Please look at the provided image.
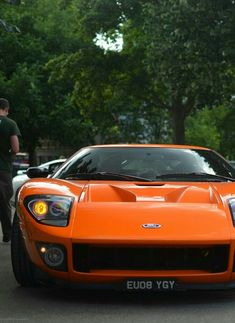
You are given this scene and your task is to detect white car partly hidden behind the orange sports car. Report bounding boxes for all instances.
[11,159,66,205]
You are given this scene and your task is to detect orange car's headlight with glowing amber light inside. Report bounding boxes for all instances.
[24,195,73,227]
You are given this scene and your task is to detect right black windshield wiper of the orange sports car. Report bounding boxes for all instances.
[156,173,235,182]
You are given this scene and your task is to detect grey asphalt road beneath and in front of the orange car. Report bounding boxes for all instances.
[0,233,235,323]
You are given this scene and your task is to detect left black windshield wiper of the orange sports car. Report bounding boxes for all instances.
[63,172,152,182]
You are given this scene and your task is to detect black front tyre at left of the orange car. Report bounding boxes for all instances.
[11,212,36,287]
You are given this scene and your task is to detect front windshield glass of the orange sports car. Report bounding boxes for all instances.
[53,146,235,181]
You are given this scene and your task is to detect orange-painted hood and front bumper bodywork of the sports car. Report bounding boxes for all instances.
[17,145,235,290]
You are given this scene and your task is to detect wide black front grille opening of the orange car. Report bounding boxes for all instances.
[73,244,229,273]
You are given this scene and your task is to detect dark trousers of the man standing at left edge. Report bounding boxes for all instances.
[0,171,13,236]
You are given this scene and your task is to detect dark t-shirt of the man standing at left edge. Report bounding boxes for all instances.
[0,116,20,173]
